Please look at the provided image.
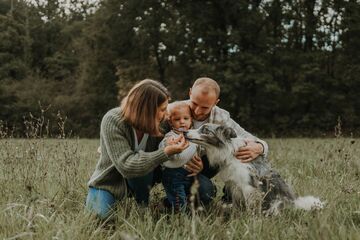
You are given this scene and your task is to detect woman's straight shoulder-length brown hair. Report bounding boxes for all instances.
[120,79,170,135]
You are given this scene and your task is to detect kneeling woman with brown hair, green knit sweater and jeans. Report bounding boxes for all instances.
[86,79,189,218]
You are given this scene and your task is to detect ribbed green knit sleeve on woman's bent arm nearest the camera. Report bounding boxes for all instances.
[100,114,168,178]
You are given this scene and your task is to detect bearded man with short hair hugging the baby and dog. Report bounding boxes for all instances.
[184,77,268,200]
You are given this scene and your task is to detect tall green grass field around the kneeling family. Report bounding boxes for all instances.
[0,138,360,239]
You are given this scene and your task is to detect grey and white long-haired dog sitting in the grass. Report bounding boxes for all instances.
[184,123,324,215]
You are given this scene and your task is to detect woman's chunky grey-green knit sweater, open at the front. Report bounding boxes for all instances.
[88,107,169,199]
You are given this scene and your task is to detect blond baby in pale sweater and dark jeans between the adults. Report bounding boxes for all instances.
[159,102,197,210]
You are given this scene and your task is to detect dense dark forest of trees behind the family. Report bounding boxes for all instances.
[0,0,360,137]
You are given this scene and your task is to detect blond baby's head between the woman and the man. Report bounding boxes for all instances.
[167,101,192,130]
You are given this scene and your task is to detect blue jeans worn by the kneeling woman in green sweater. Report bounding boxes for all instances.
[86,172,155,219]
